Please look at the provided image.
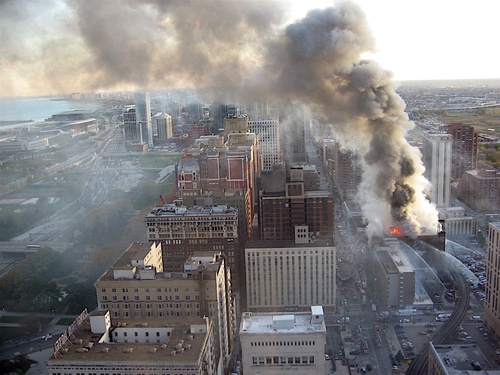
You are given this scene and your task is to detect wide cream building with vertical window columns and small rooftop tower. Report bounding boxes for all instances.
[245,239,336,311]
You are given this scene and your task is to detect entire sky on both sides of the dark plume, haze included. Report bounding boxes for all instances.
[0,0,500,97]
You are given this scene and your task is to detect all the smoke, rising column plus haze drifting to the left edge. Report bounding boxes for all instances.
[0,0,437,237]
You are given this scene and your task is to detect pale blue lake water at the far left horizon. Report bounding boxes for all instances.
[0,98,99,122]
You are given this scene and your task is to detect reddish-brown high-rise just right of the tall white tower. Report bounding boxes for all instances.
[446,123,478,179]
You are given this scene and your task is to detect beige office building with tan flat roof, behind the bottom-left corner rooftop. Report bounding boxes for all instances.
[95,243,236,372]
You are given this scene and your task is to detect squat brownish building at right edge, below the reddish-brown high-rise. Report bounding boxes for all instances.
[458,170,500,213]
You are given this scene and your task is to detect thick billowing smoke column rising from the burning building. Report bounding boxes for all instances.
[258,2,438,237]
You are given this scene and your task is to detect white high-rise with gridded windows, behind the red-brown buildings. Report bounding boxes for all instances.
[248,120,281,170]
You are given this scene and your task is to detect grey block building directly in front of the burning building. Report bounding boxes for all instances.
[373,238,415,309]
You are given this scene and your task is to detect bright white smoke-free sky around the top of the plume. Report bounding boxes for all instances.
[294,0,500,80]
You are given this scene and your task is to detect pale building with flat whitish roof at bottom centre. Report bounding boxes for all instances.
[240,306,326,375]
